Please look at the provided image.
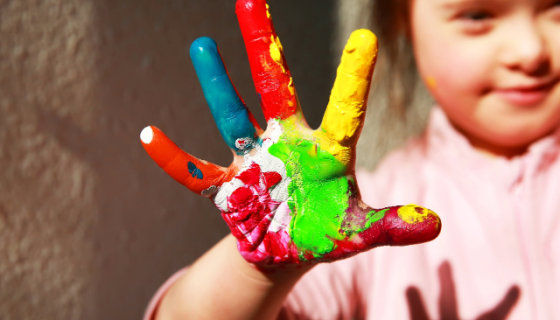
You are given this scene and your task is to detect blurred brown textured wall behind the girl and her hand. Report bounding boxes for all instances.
[0,0,432,320]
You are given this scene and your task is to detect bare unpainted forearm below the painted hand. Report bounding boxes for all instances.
[156,235,311,320]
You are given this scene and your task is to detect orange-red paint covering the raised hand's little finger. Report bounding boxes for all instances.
[140,126,231,194]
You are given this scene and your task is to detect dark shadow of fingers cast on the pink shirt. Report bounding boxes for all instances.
[406,261,521,320]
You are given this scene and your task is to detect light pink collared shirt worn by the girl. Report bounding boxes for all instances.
[145,107,560,320]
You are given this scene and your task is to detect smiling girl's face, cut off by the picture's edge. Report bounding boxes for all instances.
[410,0,560,156]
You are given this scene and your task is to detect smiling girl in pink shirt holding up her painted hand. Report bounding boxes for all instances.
[141,0,560,320]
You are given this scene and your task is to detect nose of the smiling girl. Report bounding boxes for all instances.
[502,19,550,76]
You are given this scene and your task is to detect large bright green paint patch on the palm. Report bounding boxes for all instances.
[268,140,356,256]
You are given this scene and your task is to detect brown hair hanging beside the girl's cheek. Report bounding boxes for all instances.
[372,0,418,116]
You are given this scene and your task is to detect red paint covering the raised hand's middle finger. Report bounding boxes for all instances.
[235,0,297,121]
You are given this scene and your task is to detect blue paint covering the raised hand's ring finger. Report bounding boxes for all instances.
[190,37,257,155]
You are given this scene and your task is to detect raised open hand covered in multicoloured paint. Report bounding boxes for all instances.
[141,0,441,265]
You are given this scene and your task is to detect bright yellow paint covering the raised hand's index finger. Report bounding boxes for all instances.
[321,29,377,164]
